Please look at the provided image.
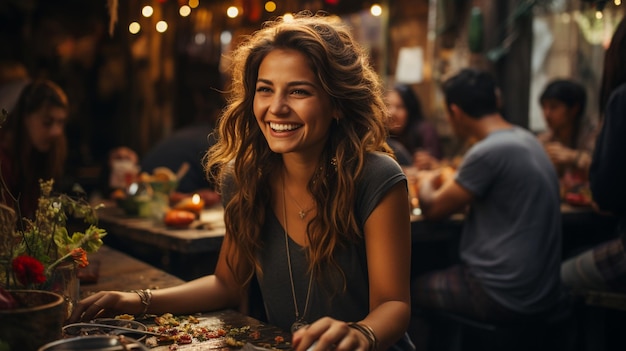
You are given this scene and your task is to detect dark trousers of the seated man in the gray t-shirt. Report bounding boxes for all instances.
[411,264,525,322]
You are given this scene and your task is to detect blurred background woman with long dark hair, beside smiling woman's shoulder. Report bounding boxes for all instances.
[386,84,442,169]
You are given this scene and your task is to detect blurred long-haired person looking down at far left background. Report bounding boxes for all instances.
[0,80,69,218]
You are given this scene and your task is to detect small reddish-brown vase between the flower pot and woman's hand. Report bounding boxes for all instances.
[44,262,80,319]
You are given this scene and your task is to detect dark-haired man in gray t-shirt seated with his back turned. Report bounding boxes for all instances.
[413,69,561,321]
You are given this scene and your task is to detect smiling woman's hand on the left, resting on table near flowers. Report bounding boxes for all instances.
[68,291,143,323]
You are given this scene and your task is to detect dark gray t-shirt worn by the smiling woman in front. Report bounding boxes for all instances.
[258,153,409,330]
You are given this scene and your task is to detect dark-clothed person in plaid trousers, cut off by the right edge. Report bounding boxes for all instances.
[561,20,626,293]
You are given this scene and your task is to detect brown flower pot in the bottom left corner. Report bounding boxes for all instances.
[0,290,66,351]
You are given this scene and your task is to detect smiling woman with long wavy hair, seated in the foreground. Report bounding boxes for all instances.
[71,12,413,351]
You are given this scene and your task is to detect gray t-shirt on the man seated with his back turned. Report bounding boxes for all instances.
[456,127,561,313]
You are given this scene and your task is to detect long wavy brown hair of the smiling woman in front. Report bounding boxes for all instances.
[206,12,392,284]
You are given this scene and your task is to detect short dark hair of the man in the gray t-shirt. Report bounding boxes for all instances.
[442,68,499,118]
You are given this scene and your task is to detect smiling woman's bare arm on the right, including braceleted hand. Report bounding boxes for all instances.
[292,183,411,351]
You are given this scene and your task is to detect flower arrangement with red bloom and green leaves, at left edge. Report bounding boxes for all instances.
[0,180,106,296]
